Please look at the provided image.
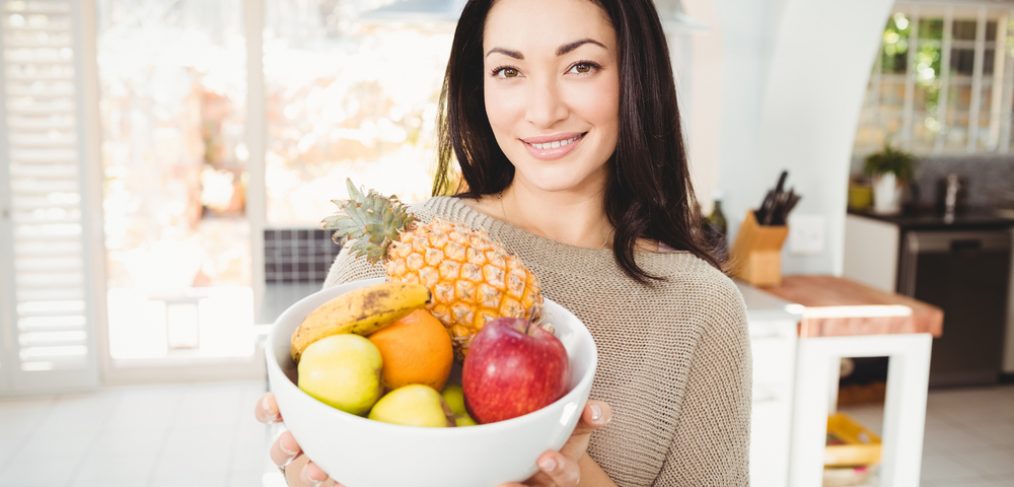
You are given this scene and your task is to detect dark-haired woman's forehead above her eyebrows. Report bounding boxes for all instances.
[483,0,615,52]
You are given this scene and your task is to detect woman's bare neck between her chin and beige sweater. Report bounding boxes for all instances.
[500,182,612,249]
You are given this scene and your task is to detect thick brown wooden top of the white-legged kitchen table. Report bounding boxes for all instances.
[762,275,944,337]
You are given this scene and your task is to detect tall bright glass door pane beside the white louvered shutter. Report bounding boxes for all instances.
[97,0,255,368]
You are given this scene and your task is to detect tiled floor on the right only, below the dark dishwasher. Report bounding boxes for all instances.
[845,386,1014,487]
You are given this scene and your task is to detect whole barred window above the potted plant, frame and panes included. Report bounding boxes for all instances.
[854,2,1014,155]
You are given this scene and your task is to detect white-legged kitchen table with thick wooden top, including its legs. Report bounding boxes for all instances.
[764,276,943,487]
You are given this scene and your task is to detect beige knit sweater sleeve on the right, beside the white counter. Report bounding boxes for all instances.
[654,281,751,487]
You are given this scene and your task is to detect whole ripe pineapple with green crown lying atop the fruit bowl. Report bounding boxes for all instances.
[322,181,542,356]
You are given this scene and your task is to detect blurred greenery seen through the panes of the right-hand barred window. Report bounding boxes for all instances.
[854,10,1014,155]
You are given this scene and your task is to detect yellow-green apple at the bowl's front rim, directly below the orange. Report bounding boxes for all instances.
[369,384,448,428]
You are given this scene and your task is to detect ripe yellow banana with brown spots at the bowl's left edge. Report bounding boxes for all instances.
[290,281,431,362]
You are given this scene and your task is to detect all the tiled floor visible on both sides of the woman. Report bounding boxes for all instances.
[0,380,1014,487]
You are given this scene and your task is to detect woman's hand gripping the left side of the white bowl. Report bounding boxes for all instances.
[255,393,342,487]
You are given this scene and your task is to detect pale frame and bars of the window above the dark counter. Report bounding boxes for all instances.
[854,1,1014,155]
